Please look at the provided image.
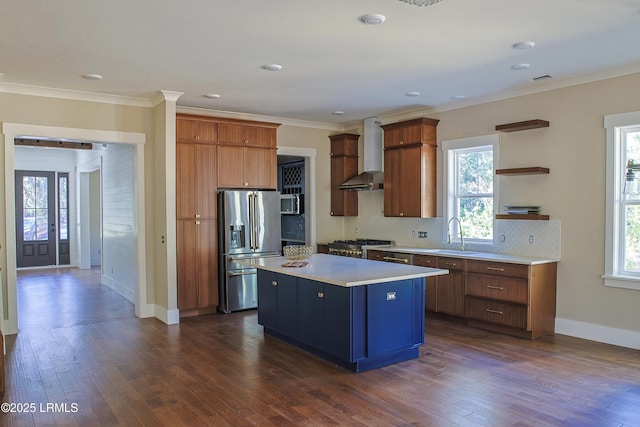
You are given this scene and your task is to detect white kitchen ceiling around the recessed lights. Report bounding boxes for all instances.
[0,0,640,124]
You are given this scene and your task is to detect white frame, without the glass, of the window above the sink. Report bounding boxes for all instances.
[441,134,500,245]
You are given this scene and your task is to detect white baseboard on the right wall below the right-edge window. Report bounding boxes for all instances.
[556,317,640,350]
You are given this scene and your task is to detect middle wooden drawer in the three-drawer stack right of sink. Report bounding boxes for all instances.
[466,273,529,304]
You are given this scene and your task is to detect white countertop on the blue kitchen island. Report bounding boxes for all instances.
[237,254,449,287]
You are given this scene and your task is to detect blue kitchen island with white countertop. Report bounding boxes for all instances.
[238,254,448,372]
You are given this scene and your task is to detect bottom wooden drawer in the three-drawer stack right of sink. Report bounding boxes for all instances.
[465,296,527,329]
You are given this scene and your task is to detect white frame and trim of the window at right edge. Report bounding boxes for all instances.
[602,111,640,290]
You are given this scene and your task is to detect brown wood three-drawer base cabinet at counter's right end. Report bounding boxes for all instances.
[466,260,557,339]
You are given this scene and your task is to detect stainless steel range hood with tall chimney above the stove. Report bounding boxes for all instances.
[338,117,384,191]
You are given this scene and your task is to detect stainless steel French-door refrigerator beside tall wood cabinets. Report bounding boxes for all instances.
[218,190,281,313]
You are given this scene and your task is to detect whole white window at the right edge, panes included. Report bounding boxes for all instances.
[603,112,640,289]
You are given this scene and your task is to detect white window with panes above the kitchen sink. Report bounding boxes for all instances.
[442,134,498,244]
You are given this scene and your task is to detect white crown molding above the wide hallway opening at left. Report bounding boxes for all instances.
[0,82,153,108]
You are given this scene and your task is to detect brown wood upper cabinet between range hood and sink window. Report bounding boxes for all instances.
[382,118,438,218]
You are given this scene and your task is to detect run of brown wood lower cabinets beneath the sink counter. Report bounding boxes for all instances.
[367,250,557,339]
